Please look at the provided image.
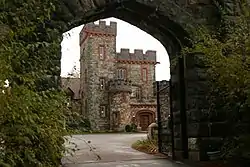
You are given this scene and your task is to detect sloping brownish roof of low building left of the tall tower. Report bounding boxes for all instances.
[61,78,80,99]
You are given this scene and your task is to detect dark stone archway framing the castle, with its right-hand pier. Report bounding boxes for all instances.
[3,0,238,162]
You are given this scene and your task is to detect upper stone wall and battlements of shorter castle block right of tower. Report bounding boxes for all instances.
[116,49,156,103]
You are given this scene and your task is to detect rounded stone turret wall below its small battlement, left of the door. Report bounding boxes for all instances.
[110,92,132,131]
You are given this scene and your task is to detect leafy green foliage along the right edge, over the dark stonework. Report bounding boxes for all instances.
[183,1,250,163]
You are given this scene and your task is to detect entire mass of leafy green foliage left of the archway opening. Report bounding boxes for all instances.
[0,0,70,167]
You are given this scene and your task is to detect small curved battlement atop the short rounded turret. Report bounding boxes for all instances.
[108,79,132,93]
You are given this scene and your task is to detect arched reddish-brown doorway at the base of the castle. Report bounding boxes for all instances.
[135,109,155,131]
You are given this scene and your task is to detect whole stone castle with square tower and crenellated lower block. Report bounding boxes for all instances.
[80,21,157,131]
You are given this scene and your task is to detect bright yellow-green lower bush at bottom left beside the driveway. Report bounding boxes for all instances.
[0,86,67,167]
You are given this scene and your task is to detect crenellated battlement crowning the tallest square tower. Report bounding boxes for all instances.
[80,20,117,35]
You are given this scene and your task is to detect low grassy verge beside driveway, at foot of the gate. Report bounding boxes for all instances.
[132,139,158,154]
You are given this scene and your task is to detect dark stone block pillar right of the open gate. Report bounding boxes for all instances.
[186,53,227,161]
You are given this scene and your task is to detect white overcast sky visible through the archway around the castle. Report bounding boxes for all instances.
[61,18,170,81]
